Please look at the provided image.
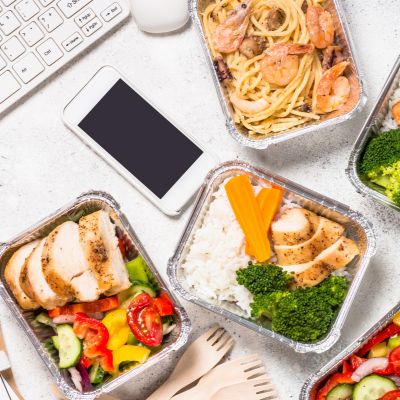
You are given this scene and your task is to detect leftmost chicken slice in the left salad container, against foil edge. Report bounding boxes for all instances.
[4,240,39,310]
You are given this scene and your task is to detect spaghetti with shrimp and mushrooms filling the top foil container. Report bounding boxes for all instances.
[202,0,350,138]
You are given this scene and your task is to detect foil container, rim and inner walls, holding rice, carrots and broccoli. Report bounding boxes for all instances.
[167,161,376,353]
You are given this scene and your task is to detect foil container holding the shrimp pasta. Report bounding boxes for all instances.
[189,0,367,149]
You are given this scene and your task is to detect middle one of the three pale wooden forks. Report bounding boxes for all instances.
[172,355,265,400]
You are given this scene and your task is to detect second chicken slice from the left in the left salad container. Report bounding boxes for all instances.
[20,239,71,310]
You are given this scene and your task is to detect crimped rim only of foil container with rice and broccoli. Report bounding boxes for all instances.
[167,160,376,353]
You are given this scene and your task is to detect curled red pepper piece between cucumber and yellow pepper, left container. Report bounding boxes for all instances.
[73,313,114,372]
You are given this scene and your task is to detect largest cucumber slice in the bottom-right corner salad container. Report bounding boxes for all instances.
[353,374,397,400]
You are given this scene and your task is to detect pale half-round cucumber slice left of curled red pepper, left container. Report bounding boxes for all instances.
[57,324,82,368]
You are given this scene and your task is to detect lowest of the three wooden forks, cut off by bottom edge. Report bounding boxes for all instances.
[210,375,279,400]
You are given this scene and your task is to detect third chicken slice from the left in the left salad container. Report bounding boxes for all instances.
[42,221,100,302]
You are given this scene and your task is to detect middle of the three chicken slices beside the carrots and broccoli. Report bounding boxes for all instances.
[275,217,344,265]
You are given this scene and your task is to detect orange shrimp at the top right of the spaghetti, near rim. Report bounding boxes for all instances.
[306,5,335,49]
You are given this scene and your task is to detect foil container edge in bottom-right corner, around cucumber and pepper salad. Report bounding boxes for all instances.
[300,303,400,400]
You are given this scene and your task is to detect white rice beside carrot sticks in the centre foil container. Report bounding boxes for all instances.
[181,182,297,317]
